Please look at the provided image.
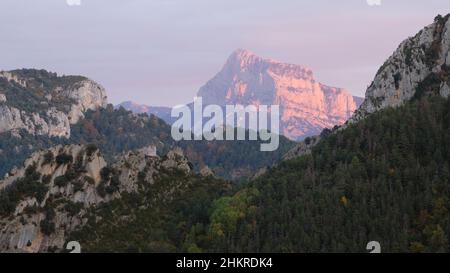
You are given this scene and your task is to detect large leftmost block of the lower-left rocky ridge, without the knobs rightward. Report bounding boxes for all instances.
[0,145,106,252]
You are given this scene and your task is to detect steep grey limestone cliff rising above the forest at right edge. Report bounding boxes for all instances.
[351,15,450,122]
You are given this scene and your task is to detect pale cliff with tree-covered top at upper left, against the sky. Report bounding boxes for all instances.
[0,70,107,138]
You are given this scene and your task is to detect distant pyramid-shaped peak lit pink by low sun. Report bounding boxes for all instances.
[198,50,362,140]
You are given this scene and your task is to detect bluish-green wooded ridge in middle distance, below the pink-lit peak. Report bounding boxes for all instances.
[0,105,294,179]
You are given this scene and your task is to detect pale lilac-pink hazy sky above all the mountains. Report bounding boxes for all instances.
[0,0,450,106]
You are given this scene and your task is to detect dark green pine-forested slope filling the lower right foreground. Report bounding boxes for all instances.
[66,97,450,252]
